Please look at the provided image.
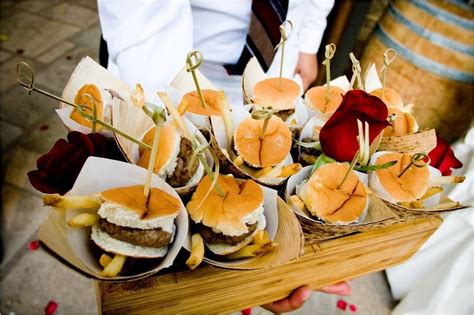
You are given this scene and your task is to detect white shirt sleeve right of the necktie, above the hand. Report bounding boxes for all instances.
[298,0,334,54]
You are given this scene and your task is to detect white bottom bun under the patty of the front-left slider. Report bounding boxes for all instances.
[91,225,168,258]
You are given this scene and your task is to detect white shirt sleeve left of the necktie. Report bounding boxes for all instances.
[98,0,193,95]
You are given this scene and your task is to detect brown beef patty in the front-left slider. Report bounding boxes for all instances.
[99,219,171,248]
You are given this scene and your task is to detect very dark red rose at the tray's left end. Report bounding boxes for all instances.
[28,131,123,195]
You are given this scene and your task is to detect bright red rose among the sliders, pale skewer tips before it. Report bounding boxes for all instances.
[319,90,390,162]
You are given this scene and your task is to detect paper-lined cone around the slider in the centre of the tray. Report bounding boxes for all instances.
[211,106,293,187]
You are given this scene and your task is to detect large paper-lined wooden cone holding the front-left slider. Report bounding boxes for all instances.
[39,157,189,281]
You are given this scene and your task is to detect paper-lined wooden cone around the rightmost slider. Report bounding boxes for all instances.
[369,151,469,213]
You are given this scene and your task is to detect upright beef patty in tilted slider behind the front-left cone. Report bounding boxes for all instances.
[166,137,199,187]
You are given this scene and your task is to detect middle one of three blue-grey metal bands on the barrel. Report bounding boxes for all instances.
[388,4,474,55]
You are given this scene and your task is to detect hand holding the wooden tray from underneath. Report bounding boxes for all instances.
[262,282,351,314]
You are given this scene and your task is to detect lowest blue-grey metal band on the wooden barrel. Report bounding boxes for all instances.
[375,24,474,83]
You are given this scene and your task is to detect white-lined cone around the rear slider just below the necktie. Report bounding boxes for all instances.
[242,57,308,129]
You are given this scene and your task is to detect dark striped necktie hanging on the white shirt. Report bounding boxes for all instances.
[224,0,288,75]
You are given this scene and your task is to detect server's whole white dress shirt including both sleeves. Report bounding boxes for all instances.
[98,0,334,102]
